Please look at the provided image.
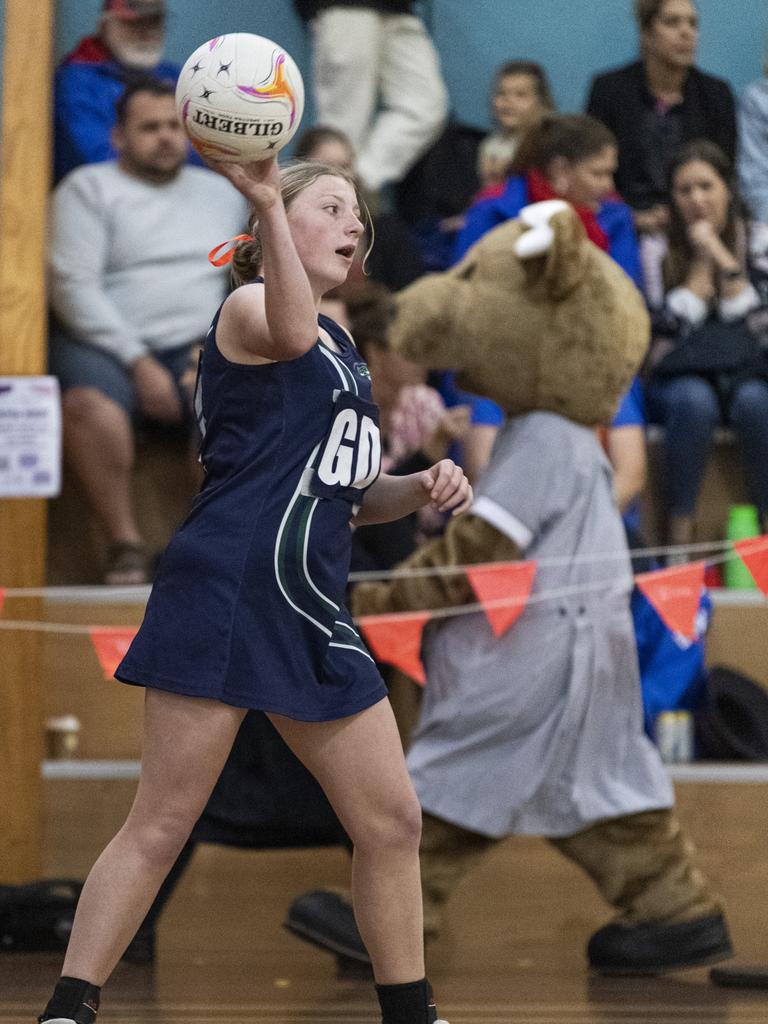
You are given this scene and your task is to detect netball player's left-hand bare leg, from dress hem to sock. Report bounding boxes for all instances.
[62,689,245,986]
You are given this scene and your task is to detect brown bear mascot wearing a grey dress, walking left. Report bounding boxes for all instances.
[287,201,731,974]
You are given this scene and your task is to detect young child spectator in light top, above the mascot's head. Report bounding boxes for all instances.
[477,60,555,199]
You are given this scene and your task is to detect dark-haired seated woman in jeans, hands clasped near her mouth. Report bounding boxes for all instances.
[648,140,768,545]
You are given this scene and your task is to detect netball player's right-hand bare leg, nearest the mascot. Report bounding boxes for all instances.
[269,699,424,985]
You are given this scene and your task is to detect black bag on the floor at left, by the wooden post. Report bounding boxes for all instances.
[0,879,83,952]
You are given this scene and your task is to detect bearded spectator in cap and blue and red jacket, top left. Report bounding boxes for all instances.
[53,0,202,181]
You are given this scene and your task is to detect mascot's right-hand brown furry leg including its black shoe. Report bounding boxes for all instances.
[550,810,732,974]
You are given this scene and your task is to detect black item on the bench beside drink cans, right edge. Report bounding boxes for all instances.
[695,666,768,761]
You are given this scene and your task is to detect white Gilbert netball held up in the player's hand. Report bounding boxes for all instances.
[176,32,304,164]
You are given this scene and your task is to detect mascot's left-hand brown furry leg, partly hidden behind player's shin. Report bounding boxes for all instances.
[419,811,498,939]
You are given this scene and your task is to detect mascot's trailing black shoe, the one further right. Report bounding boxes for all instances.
[587,913,733,975]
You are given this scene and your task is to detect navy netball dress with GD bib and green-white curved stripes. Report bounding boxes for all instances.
[116,301,386,722]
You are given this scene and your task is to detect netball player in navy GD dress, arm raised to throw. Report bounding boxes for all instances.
[40,159,472,1024]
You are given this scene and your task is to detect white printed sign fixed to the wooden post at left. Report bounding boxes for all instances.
[0,377,61,498]
